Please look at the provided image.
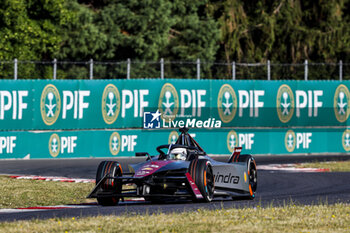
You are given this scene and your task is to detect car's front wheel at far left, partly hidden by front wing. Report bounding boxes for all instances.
[96,161,123,206]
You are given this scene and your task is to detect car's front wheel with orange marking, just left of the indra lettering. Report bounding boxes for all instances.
[189,159,214,202]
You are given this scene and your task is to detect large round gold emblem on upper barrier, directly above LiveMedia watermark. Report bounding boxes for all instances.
[158,83,179,121]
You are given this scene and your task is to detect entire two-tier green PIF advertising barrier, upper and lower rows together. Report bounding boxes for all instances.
[0,79,350,159]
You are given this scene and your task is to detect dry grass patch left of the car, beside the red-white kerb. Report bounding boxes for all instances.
[0,176,95,208]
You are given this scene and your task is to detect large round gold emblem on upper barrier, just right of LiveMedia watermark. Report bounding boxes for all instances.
[217,84,237,123]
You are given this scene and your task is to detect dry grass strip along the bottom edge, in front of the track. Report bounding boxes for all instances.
[0,204,350,233]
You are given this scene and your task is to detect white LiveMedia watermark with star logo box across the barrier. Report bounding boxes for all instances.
[143,110,222,129]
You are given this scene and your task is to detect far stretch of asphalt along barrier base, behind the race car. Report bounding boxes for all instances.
[0,155,350,179]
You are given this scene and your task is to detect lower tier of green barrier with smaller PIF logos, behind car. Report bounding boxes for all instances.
[0,128,350,159]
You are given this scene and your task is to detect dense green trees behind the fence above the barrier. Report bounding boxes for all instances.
[0,0,350,78]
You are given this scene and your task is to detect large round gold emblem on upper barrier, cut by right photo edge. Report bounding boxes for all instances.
[334,84,350,122]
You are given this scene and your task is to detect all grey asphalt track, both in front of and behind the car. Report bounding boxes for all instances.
[0,156,350,221]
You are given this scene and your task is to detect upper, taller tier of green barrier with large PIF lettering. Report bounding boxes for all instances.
[0,79,350,131]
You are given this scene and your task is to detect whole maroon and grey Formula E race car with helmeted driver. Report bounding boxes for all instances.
[88,128,257,206]
